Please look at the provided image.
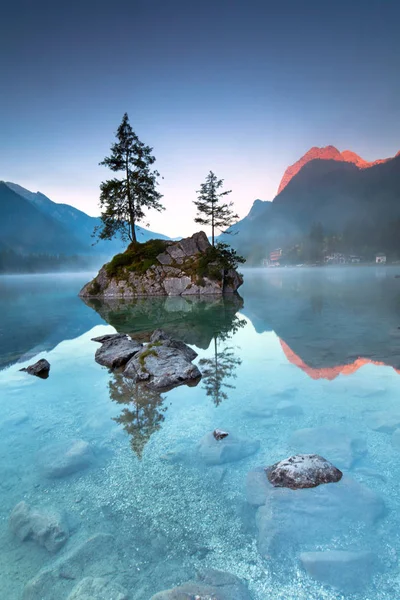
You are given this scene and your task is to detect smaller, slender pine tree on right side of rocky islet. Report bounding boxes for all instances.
[194,171,239,246]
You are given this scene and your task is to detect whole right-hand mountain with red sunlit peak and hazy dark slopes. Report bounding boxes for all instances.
[221,146,400,264]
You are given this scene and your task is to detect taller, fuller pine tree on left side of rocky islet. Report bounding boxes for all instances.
[95,113,164,242]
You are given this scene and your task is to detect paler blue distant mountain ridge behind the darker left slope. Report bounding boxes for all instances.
[4,182,169,256]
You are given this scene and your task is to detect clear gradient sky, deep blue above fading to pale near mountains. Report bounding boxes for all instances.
[0,0,400,237]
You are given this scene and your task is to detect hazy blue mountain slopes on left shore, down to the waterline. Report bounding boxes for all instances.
[0,181,169,273]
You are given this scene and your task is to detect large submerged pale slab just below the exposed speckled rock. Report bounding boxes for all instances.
[252,475,385,557]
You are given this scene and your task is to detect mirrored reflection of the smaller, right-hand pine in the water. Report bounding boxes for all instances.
[199,316,246,406]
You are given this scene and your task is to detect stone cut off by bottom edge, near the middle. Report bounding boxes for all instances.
[150,569,251,600]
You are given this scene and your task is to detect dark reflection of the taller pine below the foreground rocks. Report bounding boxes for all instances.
[109,373,167,459]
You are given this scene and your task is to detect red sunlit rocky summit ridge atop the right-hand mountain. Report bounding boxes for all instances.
[278,146,391,194]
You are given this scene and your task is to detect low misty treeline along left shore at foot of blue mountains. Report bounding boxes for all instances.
[0,250,101,273]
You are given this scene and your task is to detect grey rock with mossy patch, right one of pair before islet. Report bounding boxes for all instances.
[124,345,201,390]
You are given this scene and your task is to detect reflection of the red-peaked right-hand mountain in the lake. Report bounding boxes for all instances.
[243,267,400,380]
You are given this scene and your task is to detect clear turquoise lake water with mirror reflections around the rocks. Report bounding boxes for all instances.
[0,268,400,600]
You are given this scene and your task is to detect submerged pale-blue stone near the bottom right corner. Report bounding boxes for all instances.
[300,550,377,593]
